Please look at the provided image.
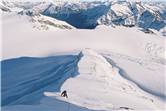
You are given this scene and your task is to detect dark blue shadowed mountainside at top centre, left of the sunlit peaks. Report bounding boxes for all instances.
[42,4,109,29]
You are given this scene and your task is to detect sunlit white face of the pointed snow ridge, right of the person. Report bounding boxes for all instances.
[61,49,165,110]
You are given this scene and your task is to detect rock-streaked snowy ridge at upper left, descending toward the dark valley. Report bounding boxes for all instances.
[0,2,74,30]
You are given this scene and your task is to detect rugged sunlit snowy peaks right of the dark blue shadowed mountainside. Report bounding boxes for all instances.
[99,1,166,30]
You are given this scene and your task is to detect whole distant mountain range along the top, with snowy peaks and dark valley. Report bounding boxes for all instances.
[2,0,166,35]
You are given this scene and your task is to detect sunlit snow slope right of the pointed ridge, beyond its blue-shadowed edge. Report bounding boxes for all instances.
[105,53,166,100]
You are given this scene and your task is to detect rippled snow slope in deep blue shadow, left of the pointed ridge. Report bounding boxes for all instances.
[1,55,79,106]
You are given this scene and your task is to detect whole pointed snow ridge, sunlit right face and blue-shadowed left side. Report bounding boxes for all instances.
[2,49,163,111]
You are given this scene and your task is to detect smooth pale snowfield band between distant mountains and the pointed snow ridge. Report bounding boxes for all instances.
[2,13,165,59]
